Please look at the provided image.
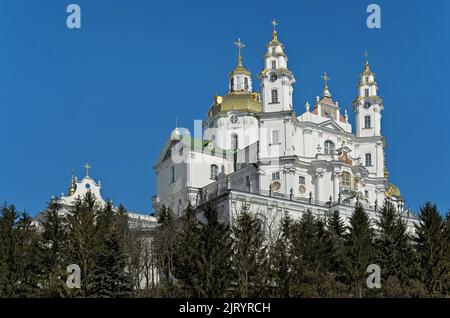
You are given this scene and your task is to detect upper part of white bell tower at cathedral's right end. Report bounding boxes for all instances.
[352,52,383,137]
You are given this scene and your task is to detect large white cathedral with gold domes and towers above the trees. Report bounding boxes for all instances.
[153,21,417,231]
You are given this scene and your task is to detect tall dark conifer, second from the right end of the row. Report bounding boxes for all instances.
[376,200,414,294]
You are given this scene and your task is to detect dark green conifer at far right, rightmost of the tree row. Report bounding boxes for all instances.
[415,202,449,297]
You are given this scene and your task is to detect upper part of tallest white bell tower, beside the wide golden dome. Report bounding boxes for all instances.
[258,20,295,112]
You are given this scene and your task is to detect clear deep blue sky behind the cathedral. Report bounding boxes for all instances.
[0,0,450,215]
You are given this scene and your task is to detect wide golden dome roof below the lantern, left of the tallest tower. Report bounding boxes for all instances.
[208,92,262,116]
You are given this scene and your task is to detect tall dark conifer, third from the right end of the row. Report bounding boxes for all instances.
[345,203,376,296]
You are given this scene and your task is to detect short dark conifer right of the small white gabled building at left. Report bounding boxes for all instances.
[92,228,133,297]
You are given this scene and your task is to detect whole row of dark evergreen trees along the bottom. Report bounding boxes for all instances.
[0,193,450,297]
